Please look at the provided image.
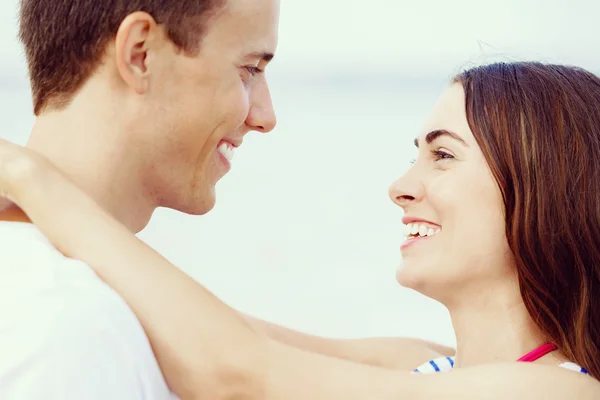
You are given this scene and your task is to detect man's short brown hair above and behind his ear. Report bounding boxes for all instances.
[19,0,225,115]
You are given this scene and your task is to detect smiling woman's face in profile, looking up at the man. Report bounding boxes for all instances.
[389,84,514,303]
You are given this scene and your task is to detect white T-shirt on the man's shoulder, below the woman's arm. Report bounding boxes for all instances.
[0,220,176,399]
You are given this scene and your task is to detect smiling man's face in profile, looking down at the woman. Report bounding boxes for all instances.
[136,0,279,214]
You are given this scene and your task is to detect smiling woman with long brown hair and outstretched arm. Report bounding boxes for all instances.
[0,63,600,399]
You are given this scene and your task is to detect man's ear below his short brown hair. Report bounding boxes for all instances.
[115,11,160,94]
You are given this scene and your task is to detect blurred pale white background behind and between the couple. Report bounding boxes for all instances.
[0,0,600,345]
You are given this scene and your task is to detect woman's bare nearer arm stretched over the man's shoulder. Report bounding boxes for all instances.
[0,141,600,400]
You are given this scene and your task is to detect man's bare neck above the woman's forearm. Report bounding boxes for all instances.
[27,98,156,232]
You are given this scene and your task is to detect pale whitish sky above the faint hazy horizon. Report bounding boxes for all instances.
[0,0,600,79]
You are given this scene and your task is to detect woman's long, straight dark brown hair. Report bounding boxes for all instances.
[454,62,600,379]
